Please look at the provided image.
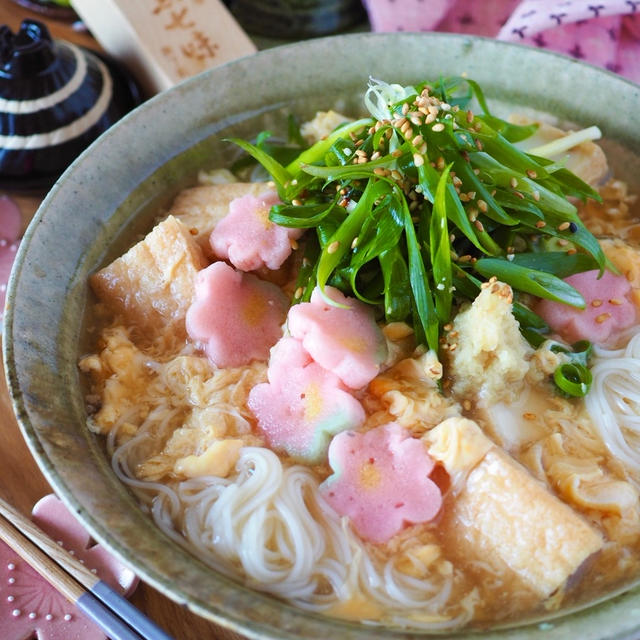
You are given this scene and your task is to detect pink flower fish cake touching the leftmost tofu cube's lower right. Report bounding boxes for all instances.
[186,262,289,368]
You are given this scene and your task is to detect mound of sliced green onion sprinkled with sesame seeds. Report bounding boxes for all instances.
[232,77,609,362]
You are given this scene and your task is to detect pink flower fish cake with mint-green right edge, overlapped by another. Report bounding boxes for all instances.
[248,337,365,464]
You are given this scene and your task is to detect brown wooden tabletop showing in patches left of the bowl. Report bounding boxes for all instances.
[0,0,244,640]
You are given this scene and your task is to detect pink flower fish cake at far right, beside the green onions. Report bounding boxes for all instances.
[535,270,637,344]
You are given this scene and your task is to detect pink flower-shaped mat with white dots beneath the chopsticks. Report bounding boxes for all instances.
[0,495,138,640]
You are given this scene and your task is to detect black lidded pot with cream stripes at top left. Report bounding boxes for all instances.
[0,20,141,190]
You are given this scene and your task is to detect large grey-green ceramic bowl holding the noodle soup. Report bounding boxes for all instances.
[4,34,640,640]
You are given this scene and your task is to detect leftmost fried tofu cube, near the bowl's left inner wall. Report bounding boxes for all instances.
[90,216,206,337]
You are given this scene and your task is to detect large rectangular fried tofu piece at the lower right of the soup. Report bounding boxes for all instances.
[424,418,603,598]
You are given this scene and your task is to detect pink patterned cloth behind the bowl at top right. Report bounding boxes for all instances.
[365,0,640,83]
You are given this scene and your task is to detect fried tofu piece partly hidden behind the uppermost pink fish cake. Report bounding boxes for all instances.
[169,182,269,258]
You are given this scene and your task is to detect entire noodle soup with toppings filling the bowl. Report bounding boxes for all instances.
[80,78,640,630]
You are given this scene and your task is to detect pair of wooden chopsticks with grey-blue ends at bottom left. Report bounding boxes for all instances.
[0,498,173,640]
